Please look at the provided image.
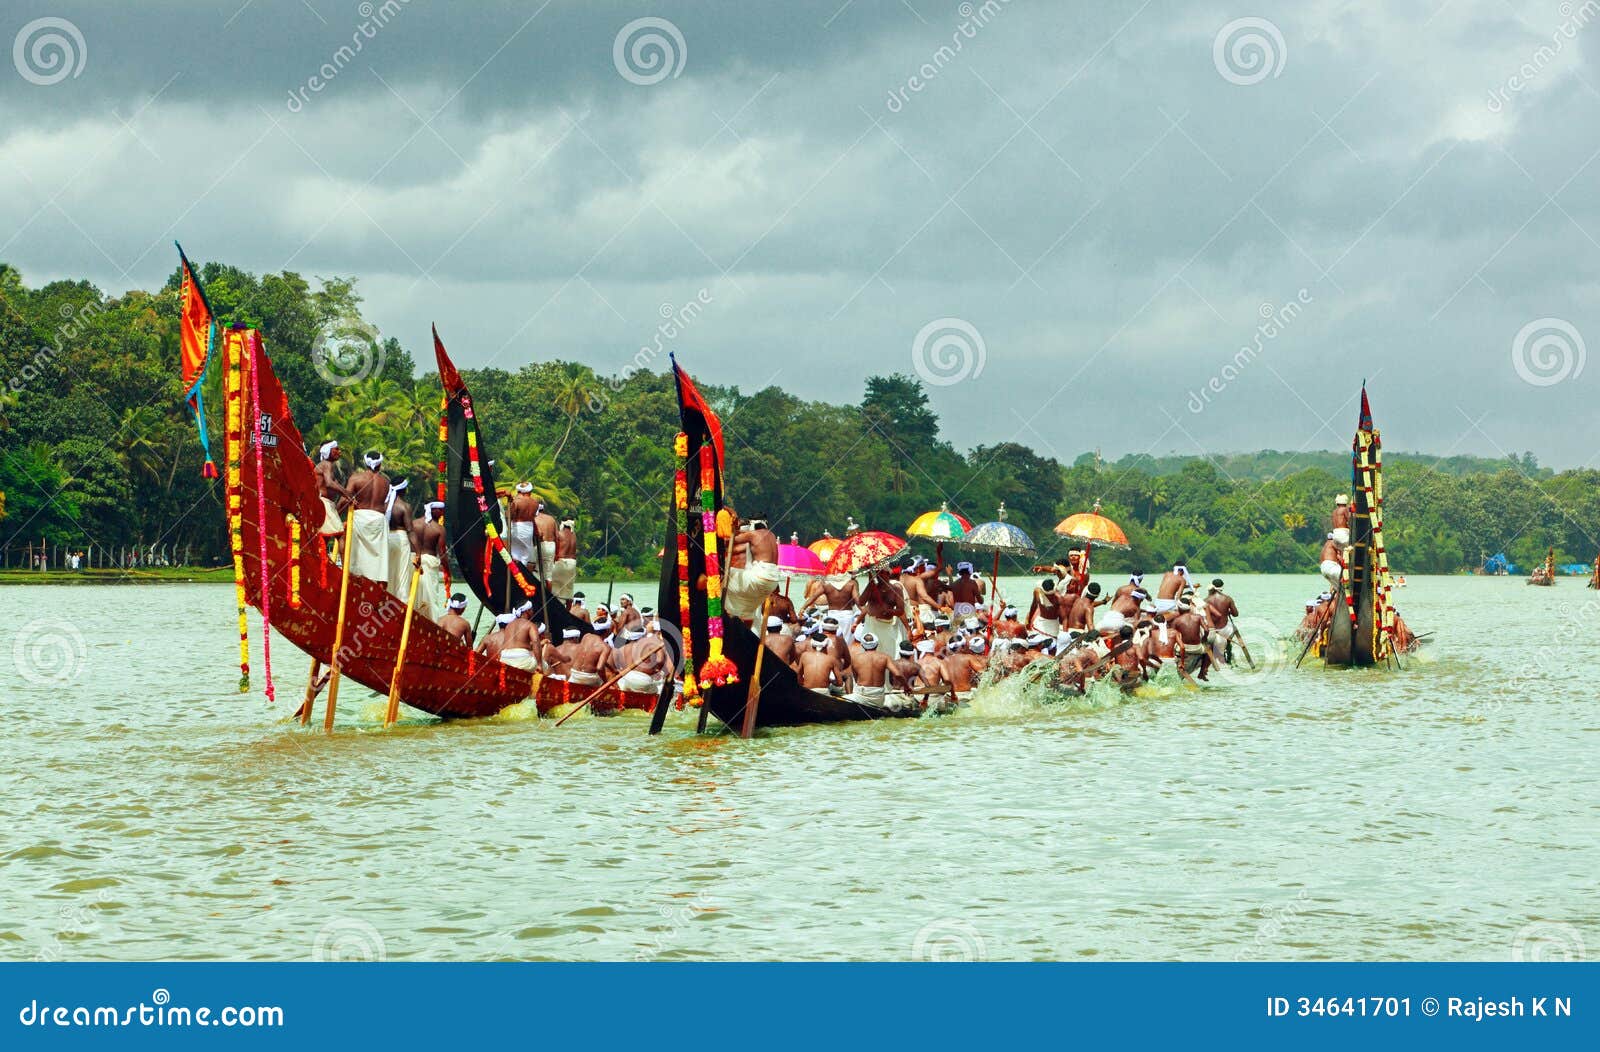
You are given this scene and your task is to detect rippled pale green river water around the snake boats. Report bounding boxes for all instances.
[0,576,1600,959]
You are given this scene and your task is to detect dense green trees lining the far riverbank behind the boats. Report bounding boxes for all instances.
[0,264,1600,572]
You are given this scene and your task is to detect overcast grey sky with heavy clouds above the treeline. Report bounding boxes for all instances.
[9,0,1600,467]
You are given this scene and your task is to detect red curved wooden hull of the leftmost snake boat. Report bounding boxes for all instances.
[224,329,554,718]
